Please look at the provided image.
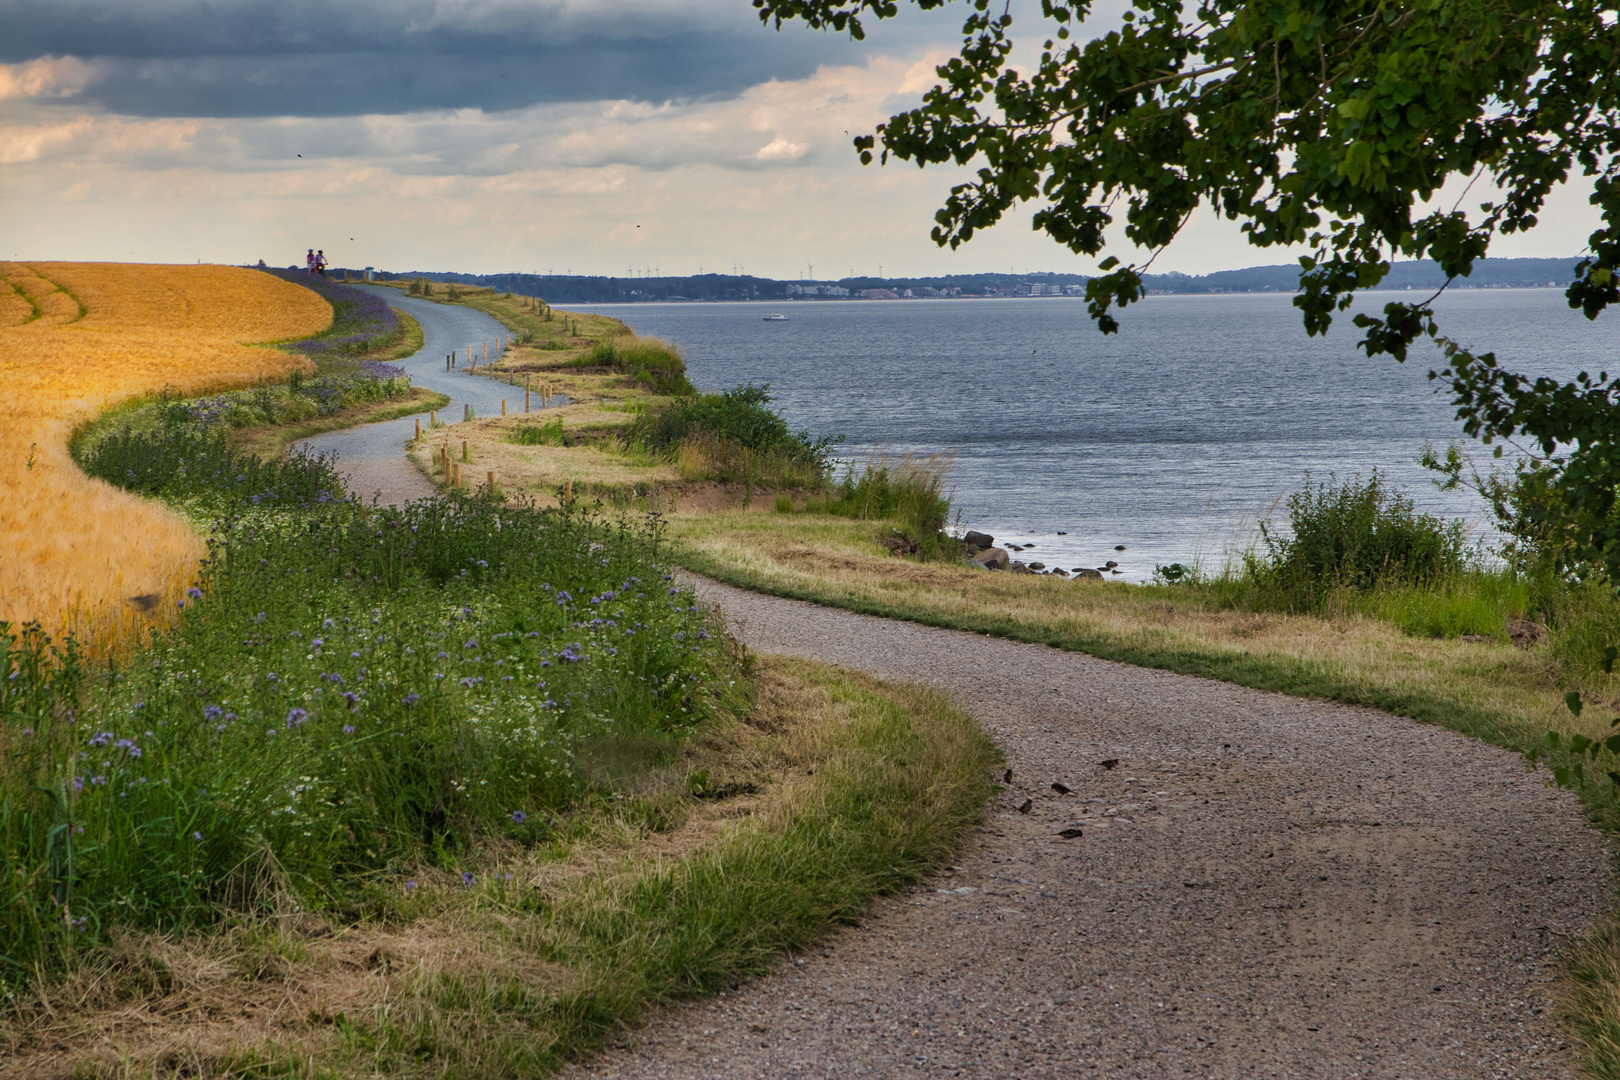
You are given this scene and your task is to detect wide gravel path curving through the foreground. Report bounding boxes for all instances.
[572,583,1610,1080]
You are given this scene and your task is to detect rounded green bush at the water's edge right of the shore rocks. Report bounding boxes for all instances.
[1246,470,1474,609]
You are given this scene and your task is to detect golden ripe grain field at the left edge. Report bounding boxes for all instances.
[0,262,332,649]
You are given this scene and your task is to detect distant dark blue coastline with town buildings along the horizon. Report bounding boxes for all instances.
[325,257,1580,304]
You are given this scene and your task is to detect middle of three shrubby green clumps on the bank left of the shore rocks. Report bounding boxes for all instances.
[622,385,836,489]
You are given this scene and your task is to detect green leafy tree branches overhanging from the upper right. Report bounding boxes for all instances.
[753,0,1620,581]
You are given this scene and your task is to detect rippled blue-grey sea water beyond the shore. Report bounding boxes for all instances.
[590,288,1620,580]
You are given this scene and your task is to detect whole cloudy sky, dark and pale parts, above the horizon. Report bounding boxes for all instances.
[0,0,1594,280]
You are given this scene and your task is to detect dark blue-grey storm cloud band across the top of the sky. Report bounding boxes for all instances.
[0,0,961,117]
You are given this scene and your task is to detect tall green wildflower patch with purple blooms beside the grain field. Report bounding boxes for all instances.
[0,426,739,984]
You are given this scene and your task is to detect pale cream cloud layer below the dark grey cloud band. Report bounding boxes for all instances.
[0,38,1591,277]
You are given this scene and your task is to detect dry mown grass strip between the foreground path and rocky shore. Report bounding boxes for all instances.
[671,513,1620,750]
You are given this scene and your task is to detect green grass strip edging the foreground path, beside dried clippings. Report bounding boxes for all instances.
[281,662,998,1077]
